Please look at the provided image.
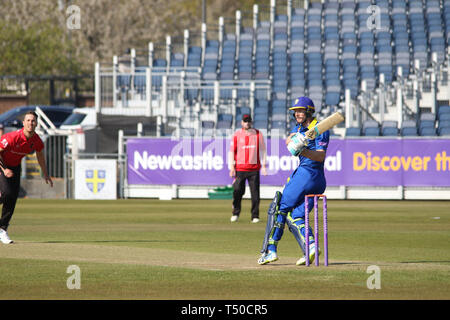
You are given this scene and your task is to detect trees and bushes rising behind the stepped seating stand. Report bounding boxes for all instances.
[0,0,284,75]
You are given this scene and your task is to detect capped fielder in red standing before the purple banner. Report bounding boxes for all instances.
[229,114,267,223]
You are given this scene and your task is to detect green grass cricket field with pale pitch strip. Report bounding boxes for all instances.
[0,199,450,300]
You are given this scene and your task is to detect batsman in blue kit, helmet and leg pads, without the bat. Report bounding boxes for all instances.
[258,97,330,265]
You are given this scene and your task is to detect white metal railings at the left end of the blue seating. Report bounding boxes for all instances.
[96,63,271,110]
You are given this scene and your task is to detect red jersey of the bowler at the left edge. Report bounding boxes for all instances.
[0,128,44,167]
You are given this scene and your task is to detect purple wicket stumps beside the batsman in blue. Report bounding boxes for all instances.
[305,194,328,267]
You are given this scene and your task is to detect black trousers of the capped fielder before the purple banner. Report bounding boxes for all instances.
[232,171,260,219]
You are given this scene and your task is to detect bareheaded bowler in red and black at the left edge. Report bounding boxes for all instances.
[0,111,53,244]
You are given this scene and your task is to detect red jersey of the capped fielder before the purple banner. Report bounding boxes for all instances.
[230,128,266,171]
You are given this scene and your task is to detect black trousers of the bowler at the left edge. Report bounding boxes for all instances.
[0,166,22,230]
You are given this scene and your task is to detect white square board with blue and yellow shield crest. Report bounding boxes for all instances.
[75,160,117,200]
